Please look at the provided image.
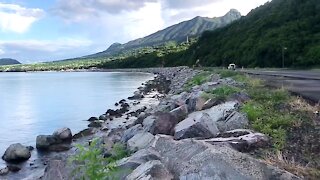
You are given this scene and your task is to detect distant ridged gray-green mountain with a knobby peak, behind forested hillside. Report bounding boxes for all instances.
[87,9,241,57]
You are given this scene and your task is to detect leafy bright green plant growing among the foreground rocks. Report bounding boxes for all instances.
[69,139,131,179]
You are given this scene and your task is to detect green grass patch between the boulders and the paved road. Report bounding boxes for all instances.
[241,79,297,151]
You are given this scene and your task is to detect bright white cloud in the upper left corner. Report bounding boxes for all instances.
[0,2,44,33]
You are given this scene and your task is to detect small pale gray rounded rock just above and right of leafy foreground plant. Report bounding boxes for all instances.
[127,132,154,151]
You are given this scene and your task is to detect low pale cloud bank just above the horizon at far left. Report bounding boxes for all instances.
[0,38,93,61]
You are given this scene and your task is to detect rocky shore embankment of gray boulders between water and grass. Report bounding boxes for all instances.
[0,67,299,180]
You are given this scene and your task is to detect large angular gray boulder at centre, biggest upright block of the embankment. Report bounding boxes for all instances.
[174,112,219,139]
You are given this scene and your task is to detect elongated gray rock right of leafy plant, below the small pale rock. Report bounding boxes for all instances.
[117,148,161,170]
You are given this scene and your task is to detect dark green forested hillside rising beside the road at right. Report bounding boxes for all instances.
[178,0,320,67]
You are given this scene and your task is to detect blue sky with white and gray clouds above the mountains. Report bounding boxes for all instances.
[0,0,268,63]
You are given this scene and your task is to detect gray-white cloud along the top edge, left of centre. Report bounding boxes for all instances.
[51,0,157,22]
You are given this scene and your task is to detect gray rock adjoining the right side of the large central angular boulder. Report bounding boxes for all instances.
[217,111,249,132]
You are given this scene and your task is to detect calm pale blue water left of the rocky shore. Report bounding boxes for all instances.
[0,72,153,163]
